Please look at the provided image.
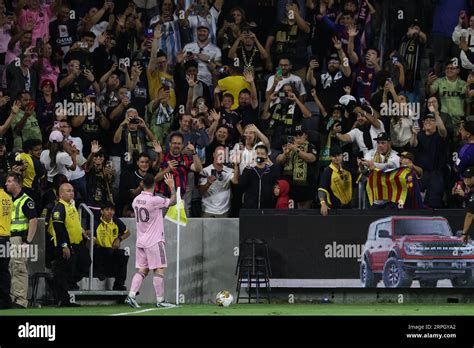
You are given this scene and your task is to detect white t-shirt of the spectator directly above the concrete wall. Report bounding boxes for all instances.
[199,164,234,215]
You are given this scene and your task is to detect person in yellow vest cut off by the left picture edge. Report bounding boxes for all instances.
[0,174,13,309]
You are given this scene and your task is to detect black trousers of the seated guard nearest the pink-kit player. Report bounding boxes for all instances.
[94,246,128,286]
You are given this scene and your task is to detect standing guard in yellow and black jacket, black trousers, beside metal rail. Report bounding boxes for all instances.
[48,183,91,307]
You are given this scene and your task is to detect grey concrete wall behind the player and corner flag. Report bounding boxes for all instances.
[63,219,239,304]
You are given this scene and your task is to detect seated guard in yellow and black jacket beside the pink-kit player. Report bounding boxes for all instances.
[94,202,130,291]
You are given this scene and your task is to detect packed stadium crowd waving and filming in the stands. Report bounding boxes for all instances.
[0,0,474,223]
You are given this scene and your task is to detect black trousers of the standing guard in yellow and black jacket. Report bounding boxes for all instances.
[52,243,91,302]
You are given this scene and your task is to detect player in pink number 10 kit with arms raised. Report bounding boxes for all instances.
[125,174,176,308]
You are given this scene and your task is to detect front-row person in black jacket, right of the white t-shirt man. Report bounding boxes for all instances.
[232,145,277,209]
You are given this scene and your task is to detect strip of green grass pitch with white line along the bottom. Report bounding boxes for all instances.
[0,303,474,316]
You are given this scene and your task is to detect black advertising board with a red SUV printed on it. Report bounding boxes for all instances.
[240,210,468,288]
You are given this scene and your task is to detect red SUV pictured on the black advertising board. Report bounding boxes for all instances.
[360,216,474,288]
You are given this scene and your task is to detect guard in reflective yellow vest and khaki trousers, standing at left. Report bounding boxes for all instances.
[6,172,38,308]
